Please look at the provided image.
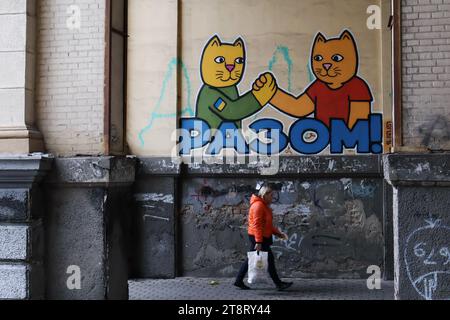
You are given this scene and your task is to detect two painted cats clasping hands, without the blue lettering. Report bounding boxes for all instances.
[196,30,373,129]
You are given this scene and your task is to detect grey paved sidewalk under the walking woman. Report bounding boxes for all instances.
[129,278,394,301]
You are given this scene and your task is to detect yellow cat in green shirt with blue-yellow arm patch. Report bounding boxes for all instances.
[196,36,276,129]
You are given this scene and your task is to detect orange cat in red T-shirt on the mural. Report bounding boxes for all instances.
[253,30,373,128]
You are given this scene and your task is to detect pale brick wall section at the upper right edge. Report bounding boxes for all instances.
[402,0,450,150]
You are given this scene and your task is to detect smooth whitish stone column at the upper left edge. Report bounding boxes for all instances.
[0,0,44,154]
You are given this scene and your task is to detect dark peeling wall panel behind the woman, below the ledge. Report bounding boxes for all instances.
[180,176,383,279]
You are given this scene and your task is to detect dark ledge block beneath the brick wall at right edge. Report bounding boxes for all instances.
[383,153,450,186]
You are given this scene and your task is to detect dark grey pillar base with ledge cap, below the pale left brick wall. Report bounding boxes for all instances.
[45,157,135,300]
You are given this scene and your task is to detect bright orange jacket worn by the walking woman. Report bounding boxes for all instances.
[248,195,281,243]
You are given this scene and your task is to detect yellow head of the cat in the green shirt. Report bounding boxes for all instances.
[201,36,245,88]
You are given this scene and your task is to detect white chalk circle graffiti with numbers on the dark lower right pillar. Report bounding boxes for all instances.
[403,220,450,300]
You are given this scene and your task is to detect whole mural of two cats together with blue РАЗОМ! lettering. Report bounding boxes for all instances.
[178,30,383,156]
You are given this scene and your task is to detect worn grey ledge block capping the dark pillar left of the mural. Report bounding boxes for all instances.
[45,157,136,187]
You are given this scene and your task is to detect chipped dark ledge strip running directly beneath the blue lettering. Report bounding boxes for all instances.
[181,155,382,177]
